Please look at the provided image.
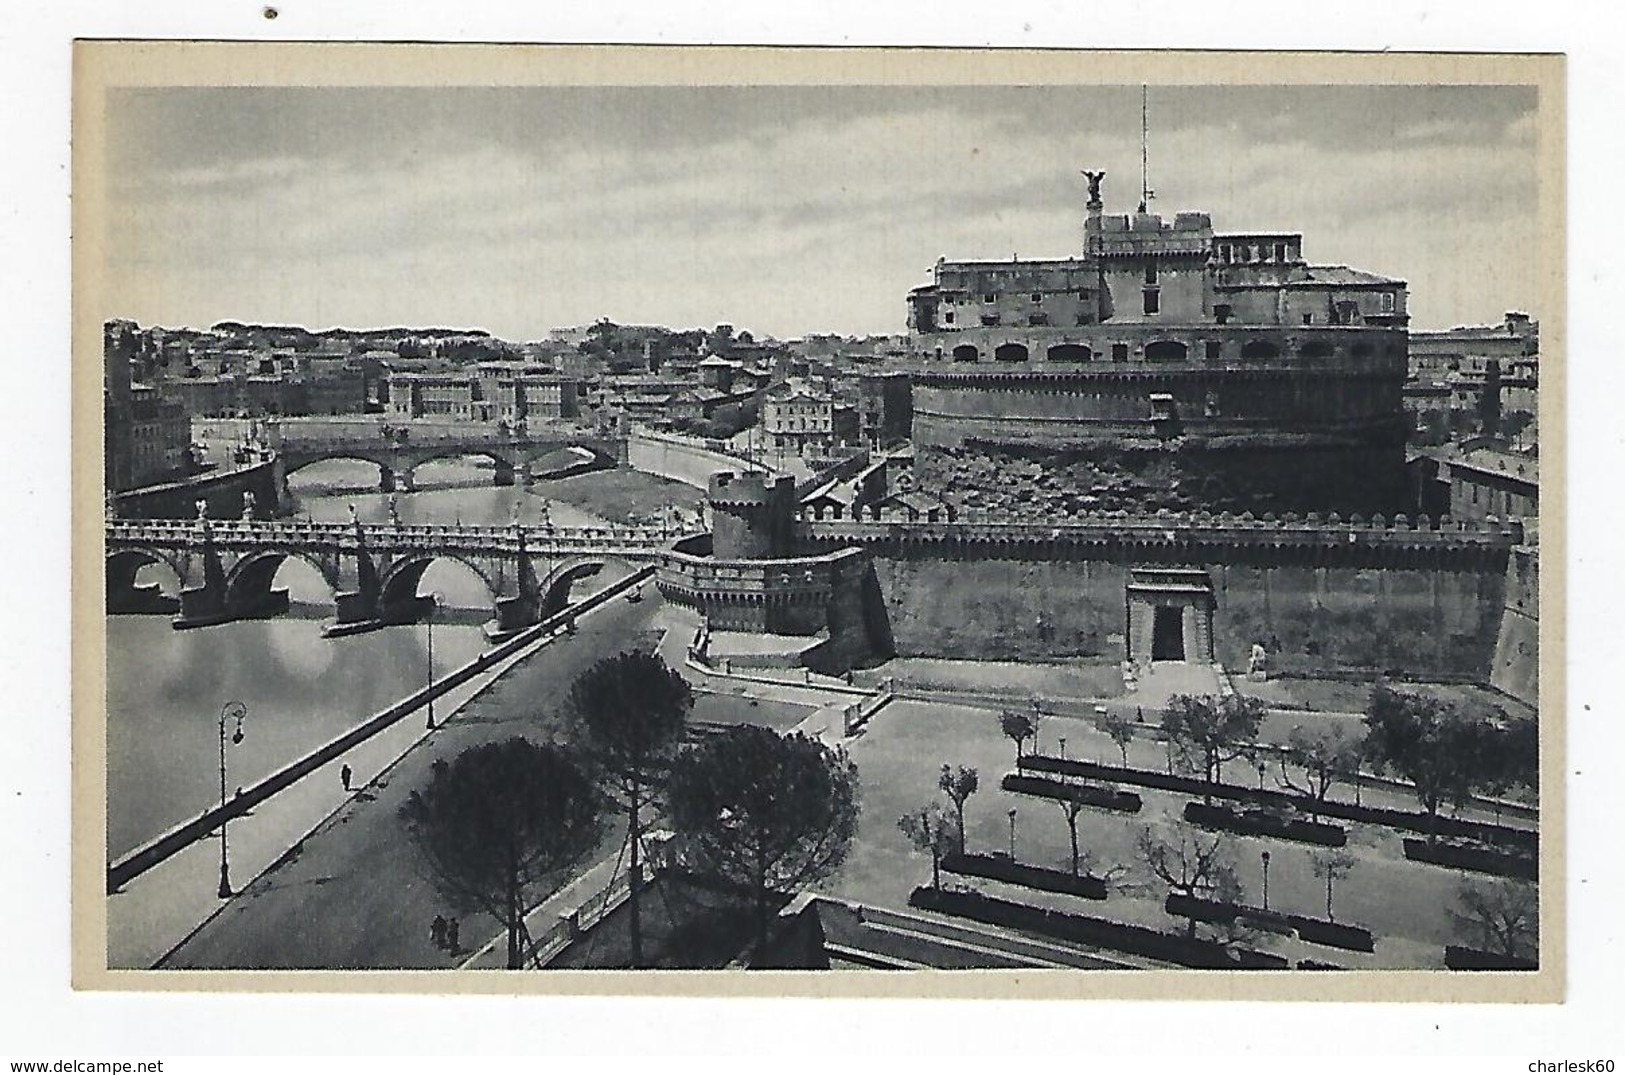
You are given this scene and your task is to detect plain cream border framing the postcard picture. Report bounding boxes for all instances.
[72,41,1567,1004]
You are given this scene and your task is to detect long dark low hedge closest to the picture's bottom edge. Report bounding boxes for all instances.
[908,887,1292,969]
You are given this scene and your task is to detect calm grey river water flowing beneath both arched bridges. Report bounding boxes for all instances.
[107,461,620,861]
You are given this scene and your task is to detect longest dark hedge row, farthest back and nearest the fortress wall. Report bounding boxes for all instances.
[1021,753,1541,853]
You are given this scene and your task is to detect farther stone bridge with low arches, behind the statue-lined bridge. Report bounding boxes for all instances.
[268,421,627,492]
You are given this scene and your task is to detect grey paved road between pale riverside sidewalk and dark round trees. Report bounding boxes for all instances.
[159,589,661,969]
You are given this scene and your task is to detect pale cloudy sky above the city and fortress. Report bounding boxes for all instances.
[104,86,1541,339]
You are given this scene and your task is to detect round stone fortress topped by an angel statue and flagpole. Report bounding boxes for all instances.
[908,172,1406,515]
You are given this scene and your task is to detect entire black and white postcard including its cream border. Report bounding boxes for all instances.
[75,42,1563,999]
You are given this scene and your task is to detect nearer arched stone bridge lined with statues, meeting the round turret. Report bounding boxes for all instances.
[106,516,681,640]
